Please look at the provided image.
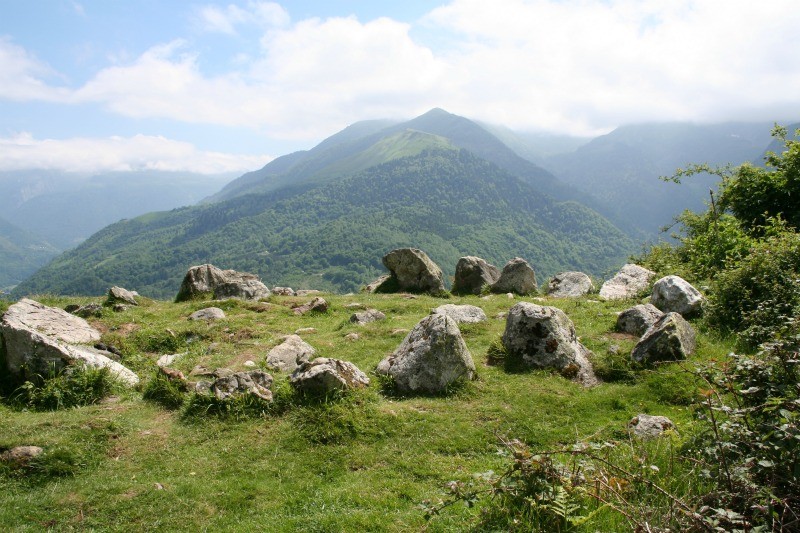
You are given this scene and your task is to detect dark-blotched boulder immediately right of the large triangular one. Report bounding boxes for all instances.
[501,302,597,386]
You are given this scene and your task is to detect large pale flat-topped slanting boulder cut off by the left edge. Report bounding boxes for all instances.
[0,298,139,385]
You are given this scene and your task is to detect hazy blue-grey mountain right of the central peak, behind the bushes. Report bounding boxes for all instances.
[539,123,772,238]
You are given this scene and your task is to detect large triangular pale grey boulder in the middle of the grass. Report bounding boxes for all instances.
[376,313,475,394]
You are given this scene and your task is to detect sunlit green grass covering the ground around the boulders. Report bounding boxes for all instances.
[0,288,732,531]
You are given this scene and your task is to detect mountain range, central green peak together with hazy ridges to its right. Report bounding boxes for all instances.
[7,109,792,298]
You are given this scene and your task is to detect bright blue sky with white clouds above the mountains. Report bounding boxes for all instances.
[0,0,800,174]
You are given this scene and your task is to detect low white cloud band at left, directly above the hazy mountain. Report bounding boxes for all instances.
[0,133,271,174]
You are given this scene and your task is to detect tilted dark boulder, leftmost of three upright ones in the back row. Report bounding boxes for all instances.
[376,248,444,294]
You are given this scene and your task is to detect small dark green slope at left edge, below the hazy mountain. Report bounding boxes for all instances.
[0,218,59,294]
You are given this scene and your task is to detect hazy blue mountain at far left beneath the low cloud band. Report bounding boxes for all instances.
[0,169,232,249]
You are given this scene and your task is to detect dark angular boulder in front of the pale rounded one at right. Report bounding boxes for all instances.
[631,313,696,363]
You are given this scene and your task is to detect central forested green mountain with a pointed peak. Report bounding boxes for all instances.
[15,132,635,298]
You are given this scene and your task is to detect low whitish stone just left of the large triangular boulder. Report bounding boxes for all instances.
[289,357,369,396]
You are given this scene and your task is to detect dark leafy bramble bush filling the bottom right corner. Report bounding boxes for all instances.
[692,319,800,531]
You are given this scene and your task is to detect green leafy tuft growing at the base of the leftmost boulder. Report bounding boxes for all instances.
[12,365,117,411]
